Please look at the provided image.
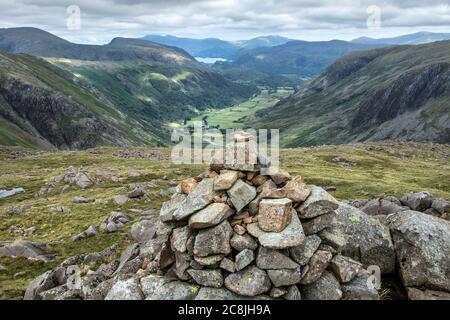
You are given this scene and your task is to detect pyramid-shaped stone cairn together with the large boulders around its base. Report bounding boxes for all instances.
[25,133,450,300]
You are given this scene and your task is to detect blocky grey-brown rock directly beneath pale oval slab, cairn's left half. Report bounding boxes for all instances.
[194,220,233,257]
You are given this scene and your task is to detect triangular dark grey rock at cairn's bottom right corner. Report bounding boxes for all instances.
[301,271,342,300]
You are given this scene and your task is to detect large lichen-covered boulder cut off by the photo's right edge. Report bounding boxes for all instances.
[388,211,450,292]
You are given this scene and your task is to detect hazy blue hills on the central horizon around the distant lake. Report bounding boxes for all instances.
[142,35,290,60]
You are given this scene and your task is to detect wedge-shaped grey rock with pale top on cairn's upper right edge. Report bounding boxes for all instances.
[297,186,339,219]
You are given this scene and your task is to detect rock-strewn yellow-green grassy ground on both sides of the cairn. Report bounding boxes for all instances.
[0,142,450,299]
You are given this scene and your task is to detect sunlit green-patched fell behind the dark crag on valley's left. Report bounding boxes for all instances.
[0,28,257,148]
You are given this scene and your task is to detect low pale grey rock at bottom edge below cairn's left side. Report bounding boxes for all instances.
[146,281,199,300]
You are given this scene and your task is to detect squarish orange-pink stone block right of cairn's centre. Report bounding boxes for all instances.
[258,199,296,232]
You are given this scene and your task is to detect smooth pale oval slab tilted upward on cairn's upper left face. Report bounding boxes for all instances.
[189,203,234,229]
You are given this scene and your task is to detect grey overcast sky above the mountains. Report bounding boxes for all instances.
[0,0,450,43]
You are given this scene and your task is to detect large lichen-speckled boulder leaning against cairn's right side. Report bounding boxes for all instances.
[336,204,395,273]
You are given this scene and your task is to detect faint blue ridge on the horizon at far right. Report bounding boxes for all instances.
[352,32,450,45]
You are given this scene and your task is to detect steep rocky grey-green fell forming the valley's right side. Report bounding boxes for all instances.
[249,41,450,147]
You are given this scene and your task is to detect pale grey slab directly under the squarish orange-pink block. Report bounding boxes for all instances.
[256,209,305,249]
